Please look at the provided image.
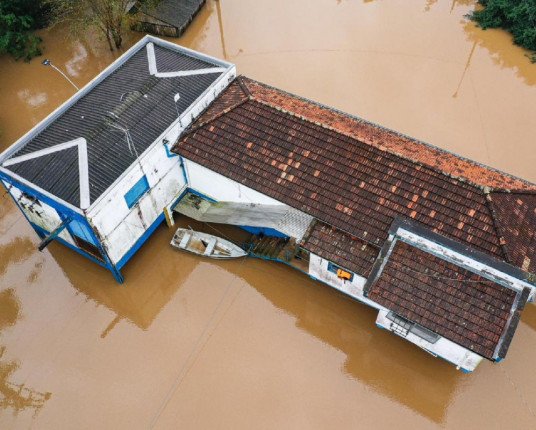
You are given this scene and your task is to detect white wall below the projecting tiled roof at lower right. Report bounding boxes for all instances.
[376,308,483,372]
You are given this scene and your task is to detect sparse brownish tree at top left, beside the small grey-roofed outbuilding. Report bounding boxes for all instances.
[48,0,138,51]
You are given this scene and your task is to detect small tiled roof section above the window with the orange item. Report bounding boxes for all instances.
[302,222,380,277]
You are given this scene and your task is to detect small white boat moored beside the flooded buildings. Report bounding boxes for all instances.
[171,228,247,258]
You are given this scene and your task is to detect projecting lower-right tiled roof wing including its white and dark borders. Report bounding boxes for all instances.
[365,223,531,360]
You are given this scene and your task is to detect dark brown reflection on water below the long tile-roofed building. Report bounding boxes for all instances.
[241,261,464,423]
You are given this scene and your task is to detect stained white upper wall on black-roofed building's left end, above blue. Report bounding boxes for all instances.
[2,181,76,246]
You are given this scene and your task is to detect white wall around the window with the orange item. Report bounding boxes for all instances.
[309,254,381,309]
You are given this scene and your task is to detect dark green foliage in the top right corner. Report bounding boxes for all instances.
[471,0,536,62]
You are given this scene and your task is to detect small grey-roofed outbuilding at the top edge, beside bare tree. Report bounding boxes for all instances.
[132,0,206,37]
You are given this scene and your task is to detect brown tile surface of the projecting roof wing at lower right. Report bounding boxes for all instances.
[366,240,517,359]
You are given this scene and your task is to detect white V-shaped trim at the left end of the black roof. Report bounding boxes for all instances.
[3,137,90,209]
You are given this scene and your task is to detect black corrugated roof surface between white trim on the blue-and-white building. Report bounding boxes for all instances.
[0,44,226,206]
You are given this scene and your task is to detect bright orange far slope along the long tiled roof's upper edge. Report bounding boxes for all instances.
[241,76,536,192]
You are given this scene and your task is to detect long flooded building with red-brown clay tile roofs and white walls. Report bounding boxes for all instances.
[173,77,536,371]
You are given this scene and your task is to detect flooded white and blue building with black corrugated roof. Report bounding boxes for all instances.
[0,36,235,282]
